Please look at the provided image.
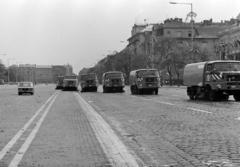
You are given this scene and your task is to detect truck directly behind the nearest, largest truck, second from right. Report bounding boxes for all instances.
[129,69,161,95]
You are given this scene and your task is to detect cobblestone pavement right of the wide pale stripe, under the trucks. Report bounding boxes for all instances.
[81,87,240,167]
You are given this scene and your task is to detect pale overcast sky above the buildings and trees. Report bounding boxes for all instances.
[0,0,240,74]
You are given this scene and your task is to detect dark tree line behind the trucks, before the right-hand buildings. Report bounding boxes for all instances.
[79,37,215,85]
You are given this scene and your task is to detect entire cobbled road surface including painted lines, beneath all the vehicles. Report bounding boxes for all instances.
[0,85,240,167]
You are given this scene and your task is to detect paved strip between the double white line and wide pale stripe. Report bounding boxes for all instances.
[14,91,109,167]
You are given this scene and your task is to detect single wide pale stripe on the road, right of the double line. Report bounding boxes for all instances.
[74,93,139,167]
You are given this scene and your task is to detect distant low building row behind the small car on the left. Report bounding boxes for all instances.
[9,64,73,83]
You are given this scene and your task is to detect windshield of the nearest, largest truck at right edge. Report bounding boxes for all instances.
[213,62,240,71]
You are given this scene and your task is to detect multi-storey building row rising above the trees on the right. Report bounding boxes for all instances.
[122,14,240,60]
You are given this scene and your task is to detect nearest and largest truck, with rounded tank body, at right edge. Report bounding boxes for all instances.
[183,60,240,101]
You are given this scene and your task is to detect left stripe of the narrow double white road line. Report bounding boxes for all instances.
[0,92,57,161]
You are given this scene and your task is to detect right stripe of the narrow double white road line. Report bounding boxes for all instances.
[8,91,59,167]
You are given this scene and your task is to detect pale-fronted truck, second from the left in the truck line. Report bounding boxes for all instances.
[62,75,79,91]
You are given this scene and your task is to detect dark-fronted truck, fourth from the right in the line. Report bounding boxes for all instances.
[80,73,98,92]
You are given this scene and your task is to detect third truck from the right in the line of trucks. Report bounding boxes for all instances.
[102,71,125,93]
